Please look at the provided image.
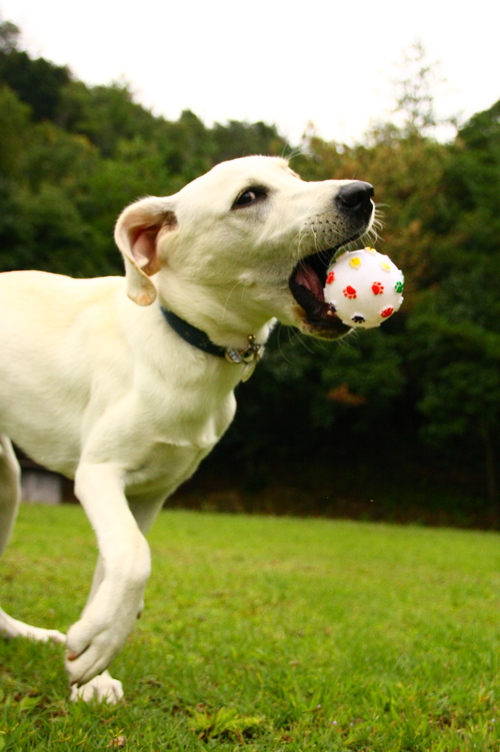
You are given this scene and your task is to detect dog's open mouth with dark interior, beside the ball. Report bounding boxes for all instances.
[289,248,349,339]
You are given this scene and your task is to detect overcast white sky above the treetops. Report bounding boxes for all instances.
[0,0,500,144]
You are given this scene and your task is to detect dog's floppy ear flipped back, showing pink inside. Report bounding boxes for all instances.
[115,196,177,306]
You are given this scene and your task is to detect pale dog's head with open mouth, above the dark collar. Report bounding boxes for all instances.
[116,157,374,339]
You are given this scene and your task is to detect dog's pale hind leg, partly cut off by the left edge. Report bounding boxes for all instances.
[0,434,66,642]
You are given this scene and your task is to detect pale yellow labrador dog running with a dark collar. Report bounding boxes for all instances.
[0,156,374,702]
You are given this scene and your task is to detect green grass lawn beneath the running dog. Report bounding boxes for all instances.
[0,506,500,752]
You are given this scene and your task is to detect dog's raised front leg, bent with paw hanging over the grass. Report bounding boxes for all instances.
[66,462,151,685]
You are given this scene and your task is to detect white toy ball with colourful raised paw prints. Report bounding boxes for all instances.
[325,248,404,329]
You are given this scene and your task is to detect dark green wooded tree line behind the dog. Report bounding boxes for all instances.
[0,22,500,523]
